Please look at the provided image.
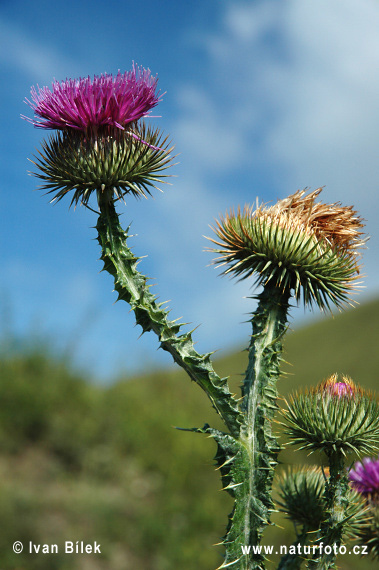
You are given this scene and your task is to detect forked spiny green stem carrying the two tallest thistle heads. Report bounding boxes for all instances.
[97,199,290,570]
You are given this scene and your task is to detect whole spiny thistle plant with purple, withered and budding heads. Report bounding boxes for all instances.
[26,67,379,570]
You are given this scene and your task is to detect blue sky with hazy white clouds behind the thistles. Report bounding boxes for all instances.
[0,0,379,378]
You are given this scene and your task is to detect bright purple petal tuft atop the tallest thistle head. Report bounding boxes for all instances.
[23,65,161,133]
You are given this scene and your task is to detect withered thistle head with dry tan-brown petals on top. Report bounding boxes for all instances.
[211,188,365,309]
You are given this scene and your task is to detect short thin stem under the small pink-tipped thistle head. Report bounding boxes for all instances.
[308,450,349,570]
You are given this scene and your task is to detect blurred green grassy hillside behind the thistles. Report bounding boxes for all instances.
[0,301,379,570]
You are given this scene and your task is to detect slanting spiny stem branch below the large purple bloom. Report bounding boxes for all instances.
[96,199,241,435]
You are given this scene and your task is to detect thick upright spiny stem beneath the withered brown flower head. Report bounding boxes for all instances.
[224,284,290,570]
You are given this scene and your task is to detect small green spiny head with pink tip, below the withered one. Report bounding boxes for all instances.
[282,374,379,455]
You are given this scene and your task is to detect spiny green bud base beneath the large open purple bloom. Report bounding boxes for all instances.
[34,123,172,205]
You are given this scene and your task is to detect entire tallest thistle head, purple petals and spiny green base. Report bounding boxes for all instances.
[27,66,172,205]
